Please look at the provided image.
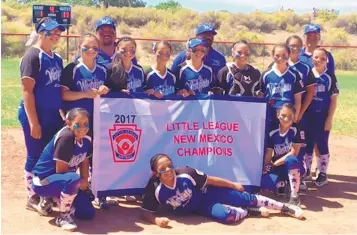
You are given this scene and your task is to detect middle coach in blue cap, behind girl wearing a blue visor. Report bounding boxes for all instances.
[171,24,226,80]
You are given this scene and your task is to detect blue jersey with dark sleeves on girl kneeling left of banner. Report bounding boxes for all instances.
[32,126,92,180]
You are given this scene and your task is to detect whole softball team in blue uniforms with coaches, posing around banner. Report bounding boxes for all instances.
[18,17,339,231]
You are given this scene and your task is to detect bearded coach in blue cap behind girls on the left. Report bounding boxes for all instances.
[95,16,137,69]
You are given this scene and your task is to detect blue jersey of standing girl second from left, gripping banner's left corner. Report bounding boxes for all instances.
[61,61,107,116]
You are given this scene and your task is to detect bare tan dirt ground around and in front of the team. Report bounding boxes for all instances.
[1,129,357,234]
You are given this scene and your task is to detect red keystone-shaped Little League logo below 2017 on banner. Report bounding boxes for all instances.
[109,124,141,162]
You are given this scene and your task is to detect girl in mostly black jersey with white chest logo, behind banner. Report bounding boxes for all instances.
[218,40,260,96]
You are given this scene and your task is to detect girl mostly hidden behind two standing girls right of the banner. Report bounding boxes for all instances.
[286,35,316,190]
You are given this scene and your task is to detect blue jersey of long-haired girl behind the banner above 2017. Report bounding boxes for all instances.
[126,63,145,92]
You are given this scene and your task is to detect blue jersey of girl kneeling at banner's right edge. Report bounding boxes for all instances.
[267,122,305,162]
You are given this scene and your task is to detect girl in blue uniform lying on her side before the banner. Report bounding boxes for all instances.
[141,154,303,228]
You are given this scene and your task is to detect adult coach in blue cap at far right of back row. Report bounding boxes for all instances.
[299,24,335,74]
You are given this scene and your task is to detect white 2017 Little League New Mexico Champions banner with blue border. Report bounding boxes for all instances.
[92,93,266,196]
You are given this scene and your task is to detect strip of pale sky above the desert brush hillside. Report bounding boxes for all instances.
[145,0,357,13]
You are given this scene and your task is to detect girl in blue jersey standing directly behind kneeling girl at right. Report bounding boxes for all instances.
[260,44,304,124]
